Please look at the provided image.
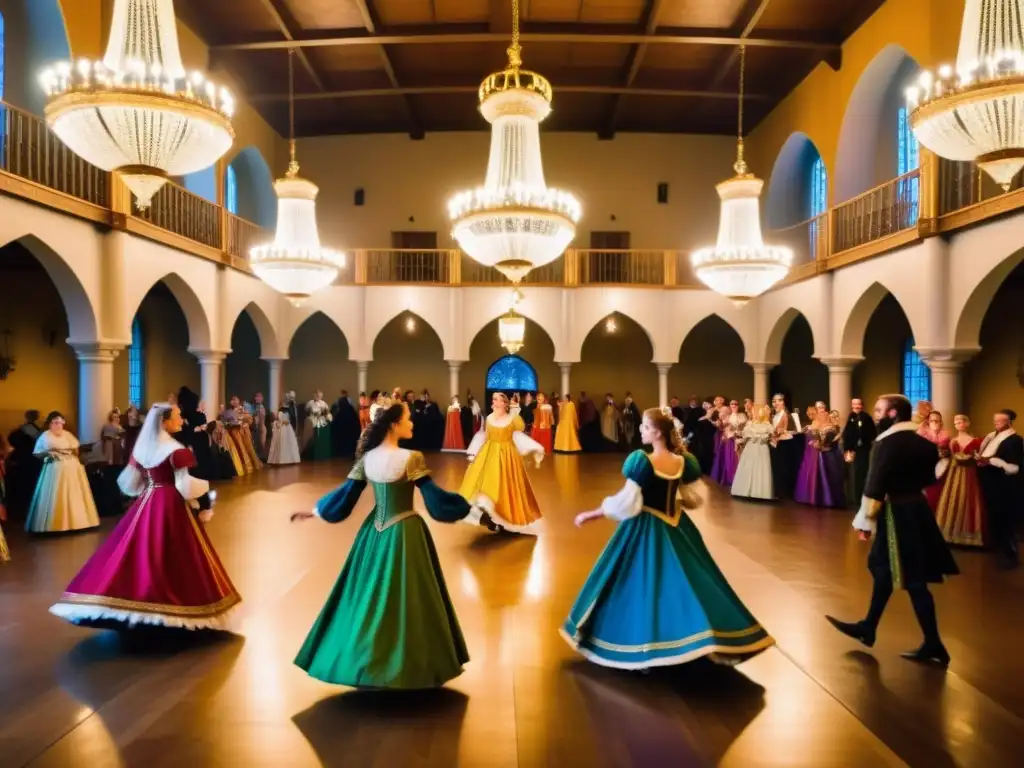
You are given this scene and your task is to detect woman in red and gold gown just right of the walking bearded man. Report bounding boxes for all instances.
[935,414,987,547]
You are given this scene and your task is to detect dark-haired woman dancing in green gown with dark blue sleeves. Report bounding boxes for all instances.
[292,402,497,689]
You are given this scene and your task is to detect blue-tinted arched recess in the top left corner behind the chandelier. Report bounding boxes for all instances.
[3,0,71,116]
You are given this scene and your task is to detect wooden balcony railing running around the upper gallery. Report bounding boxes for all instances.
[6,92,1024,288]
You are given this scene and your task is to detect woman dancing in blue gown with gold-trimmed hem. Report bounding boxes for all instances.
[560,409,775,670]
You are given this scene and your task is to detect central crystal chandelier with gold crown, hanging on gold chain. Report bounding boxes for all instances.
[449,0,581,283]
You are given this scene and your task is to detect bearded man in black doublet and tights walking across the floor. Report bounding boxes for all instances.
[825,394,959,666]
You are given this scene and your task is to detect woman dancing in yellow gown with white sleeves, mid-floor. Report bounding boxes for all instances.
[459,392,544,534]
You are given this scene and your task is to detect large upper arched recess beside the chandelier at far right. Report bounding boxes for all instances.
[831,43,920,203]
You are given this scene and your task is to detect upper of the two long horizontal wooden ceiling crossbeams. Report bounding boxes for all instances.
[211,27,840,53]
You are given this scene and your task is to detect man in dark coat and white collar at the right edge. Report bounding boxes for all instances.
[977,409,1024,568]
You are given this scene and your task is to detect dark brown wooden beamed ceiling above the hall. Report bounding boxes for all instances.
[175,0,884,137]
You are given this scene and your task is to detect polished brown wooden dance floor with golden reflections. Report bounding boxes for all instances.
[0,455,1024,768]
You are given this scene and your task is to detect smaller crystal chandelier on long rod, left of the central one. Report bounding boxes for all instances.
[249,48,345,305]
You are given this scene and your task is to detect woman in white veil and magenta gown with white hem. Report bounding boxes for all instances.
[50,402,242,630]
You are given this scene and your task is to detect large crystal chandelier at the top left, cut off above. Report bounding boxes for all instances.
[40,0,234,210]
